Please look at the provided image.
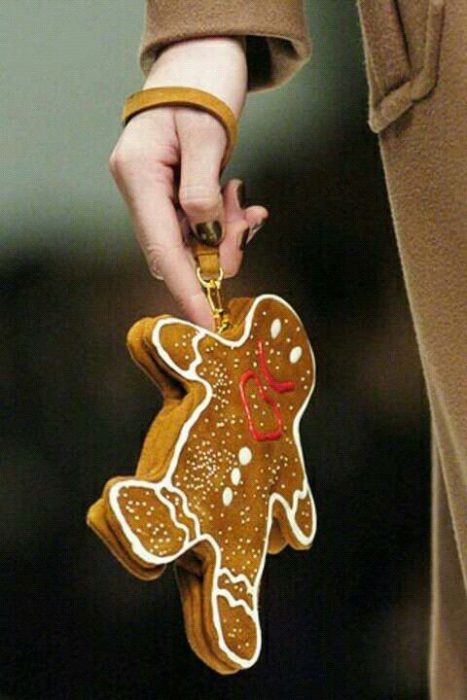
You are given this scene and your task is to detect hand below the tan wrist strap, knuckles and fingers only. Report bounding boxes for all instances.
[109,107,268,329]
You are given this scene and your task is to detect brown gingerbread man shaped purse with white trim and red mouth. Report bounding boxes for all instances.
[90,295,316,673]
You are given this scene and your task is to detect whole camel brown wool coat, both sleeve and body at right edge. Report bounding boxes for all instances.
[139,0,467,700]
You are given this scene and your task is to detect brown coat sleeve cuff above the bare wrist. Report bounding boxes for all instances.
[139,0,311,91]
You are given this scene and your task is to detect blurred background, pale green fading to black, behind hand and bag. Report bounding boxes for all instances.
[0,0,429,700]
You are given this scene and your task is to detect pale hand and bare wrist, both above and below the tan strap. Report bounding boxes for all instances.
[109,37,268,328]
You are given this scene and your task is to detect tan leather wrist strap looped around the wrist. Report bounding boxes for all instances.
[122,86,238,167]
